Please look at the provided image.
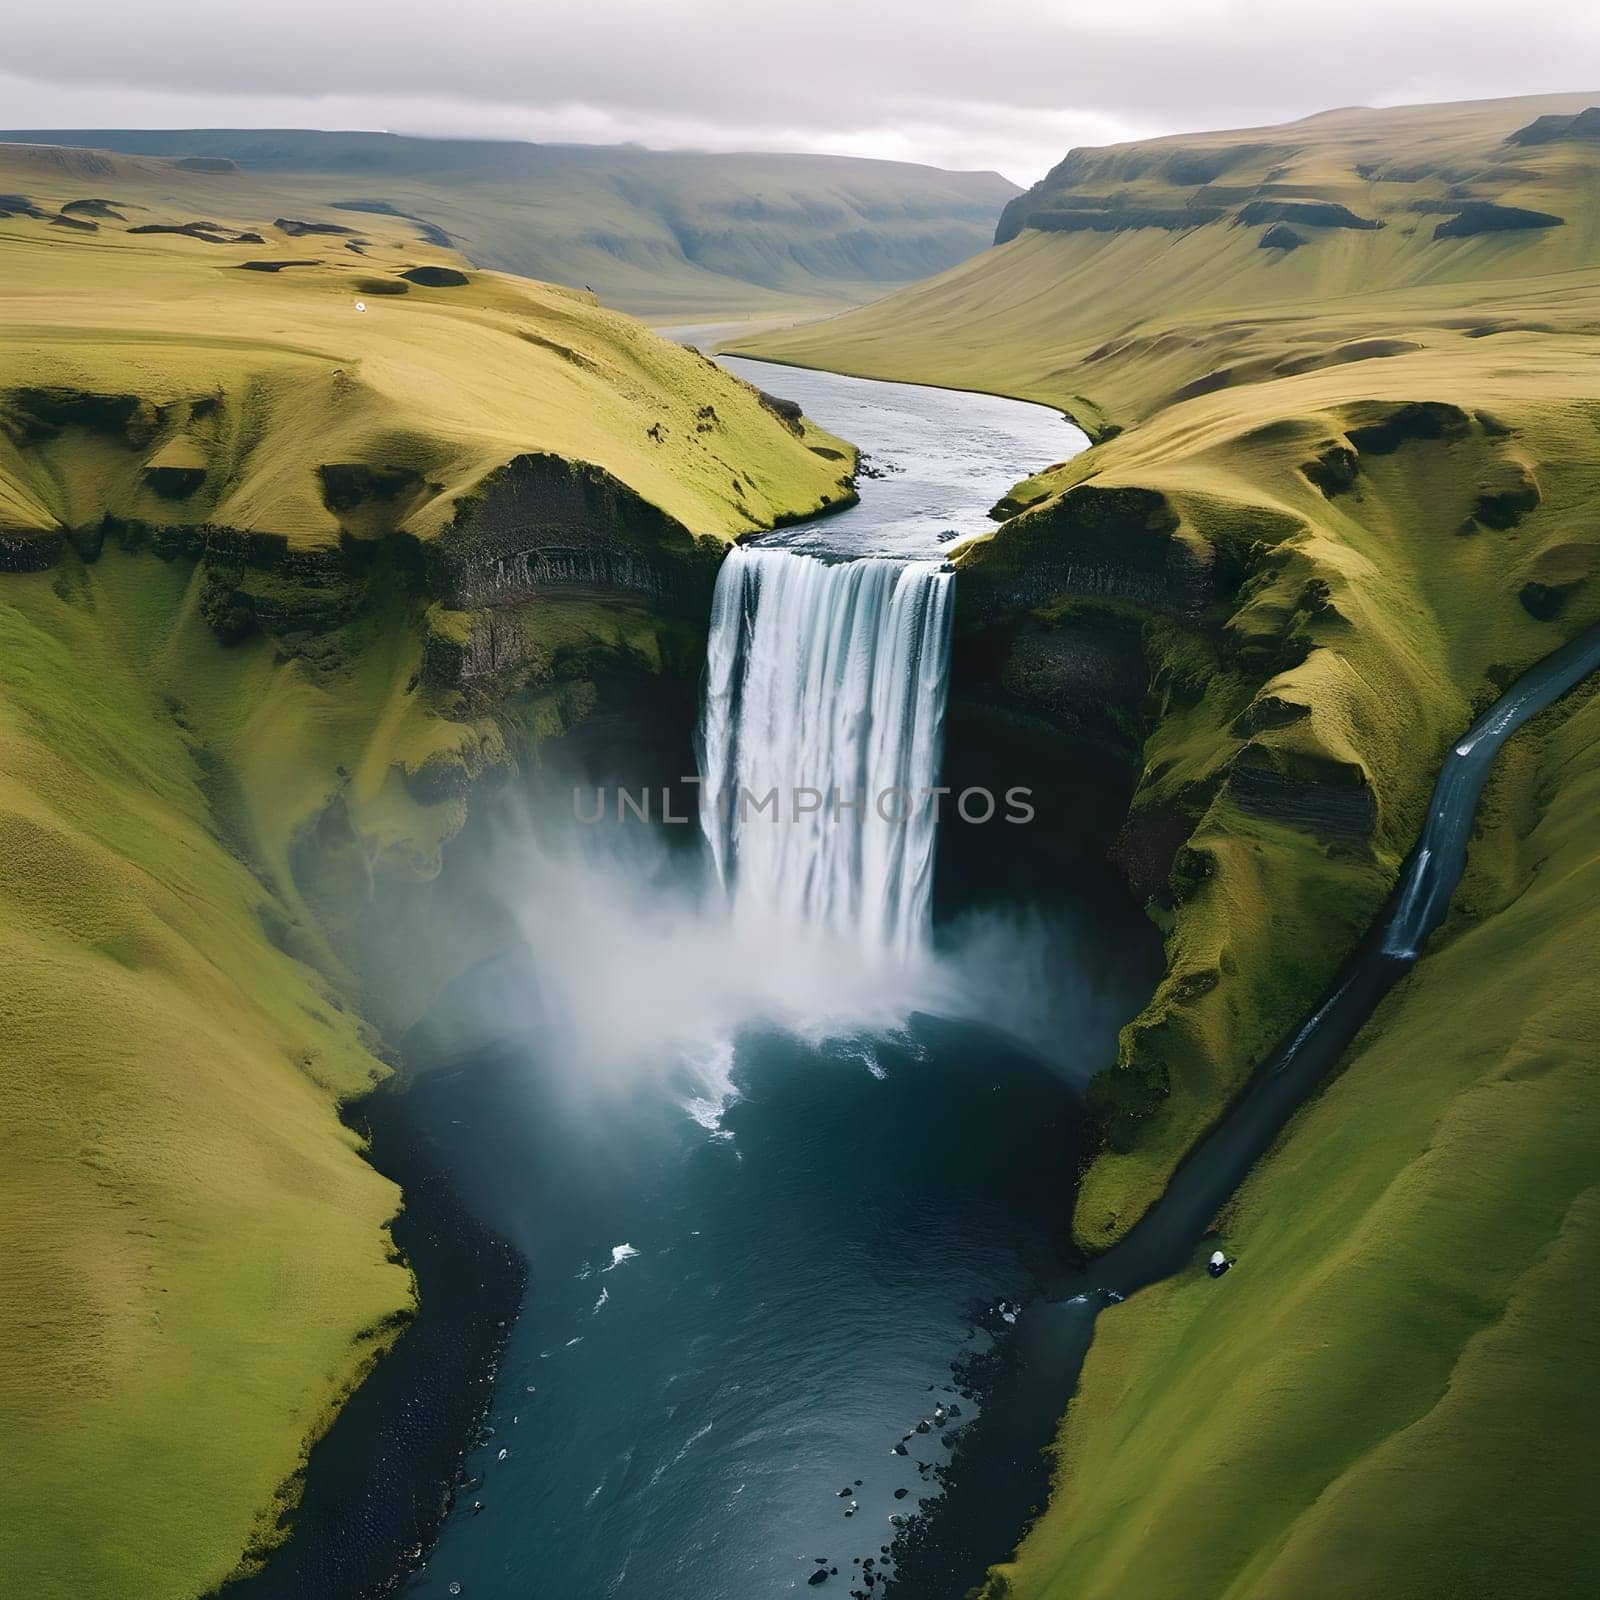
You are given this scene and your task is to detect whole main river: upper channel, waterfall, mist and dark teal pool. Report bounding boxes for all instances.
[384,362,1126,1600]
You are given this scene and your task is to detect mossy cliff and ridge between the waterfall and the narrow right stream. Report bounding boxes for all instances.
[950,400,1600,1248]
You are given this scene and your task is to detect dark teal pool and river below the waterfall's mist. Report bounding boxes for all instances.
[406,1019,1100,1600]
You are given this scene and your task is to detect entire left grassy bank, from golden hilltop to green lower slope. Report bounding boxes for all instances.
[0,140,851,1600]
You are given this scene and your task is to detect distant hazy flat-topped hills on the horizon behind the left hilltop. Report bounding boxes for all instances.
[0,130,1018,322]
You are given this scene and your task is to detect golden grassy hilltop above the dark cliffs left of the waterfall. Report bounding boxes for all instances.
[0,146,840,546]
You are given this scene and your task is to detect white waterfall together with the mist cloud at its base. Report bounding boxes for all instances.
[441,550,1120,1128]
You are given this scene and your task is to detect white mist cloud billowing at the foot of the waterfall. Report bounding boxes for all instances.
[478,811,1126,1128]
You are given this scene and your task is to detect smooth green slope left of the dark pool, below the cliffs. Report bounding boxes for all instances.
[0,557,411,1597]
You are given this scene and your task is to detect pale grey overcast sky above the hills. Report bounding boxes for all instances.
[0,0,1600,182]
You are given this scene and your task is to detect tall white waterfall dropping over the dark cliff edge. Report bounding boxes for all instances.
[699,549,955,960]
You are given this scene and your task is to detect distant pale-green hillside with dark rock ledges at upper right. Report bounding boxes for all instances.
[739,93,1600,406]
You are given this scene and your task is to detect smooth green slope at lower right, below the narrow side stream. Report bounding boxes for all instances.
[990,672,1600,1600]
